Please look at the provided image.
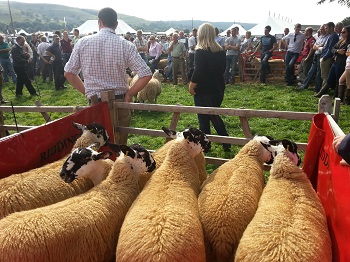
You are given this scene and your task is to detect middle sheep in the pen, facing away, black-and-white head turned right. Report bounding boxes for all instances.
[116,128,210,262]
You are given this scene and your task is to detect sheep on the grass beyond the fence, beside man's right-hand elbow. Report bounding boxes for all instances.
[129,70,162,104]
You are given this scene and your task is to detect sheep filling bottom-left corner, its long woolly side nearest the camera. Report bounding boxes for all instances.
[0,145,155,262]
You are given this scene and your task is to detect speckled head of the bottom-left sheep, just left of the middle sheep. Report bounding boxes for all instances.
[120,144,156,173]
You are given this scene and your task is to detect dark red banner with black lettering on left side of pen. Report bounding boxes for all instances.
[0,102,114,178]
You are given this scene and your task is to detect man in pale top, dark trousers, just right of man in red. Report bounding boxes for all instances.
[299,25,327,93]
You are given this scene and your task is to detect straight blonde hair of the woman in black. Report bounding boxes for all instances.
[196,23,223,53]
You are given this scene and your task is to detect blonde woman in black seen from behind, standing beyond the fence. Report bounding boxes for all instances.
[189,23,231,152]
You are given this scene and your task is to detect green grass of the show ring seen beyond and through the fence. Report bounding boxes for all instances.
[3,78,350,172]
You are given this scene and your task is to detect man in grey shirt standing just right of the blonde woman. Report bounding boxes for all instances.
[225,27,241,85]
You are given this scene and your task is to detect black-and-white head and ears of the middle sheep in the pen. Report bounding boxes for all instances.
[162,127,211,155]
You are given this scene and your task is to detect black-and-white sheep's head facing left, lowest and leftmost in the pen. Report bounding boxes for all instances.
[60,143,112,183]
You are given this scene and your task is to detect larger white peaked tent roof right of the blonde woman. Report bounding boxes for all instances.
[249,16,294,36]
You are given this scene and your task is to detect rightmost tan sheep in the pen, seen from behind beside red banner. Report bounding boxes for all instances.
[235,150,332,262]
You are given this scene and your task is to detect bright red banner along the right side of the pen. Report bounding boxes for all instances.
[303,114,350,262]
